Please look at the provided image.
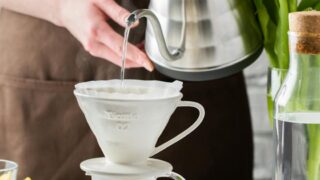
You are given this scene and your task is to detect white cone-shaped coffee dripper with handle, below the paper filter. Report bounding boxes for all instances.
[74,80,204,164]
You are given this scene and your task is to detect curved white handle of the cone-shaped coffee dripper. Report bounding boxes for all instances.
[151,101,205,156]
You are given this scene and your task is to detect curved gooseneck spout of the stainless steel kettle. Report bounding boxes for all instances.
[126,9,185,61]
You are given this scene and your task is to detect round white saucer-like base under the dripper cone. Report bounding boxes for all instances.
[80,158,173,178]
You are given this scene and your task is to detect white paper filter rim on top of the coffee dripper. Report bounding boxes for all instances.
[75,79,182,100]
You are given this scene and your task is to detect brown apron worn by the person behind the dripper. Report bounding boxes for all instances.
[0,1,252,180]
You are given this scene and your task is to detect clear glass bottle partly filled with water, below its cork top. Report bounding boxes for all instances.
[274,32,320,180]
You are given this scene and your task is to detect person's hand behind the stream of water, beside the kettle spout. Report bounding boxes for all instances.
[58,0,153,71]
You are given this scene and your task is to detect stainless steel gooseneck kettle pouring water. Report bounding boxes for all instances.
[129,0,262,81]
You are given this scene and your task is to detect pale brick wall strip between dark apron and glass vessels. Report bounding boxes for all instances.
[245,53,273,180]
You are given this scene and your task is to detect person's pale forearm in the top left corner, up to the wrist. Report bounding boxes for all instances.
[0,0,60,25]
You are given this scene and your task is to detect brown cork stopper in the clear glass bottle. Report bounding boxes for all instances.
[289,11,320,54]
